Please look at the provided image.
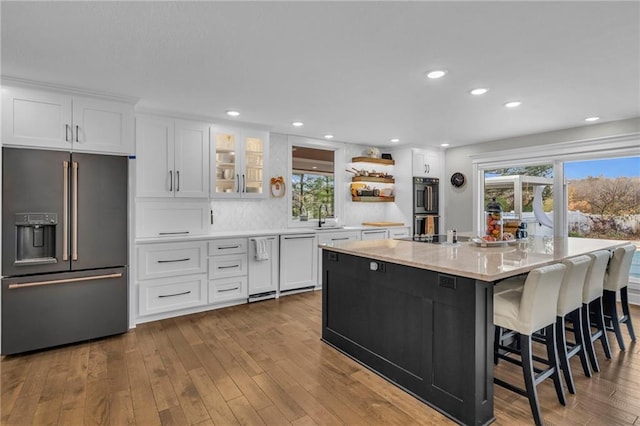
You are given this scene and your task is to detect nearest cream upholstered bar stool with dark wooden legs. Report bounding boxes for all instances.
[493,264,567,425]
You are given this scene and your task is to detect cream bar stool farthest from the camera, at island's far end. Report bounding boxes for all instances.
[603,244,636,351]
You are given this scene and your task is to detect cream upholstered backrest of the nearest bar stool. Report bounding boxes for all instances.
[519,263,567,332]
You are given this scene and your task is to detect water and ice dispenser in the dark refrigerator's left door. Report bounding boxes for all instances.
[14,213,58,266]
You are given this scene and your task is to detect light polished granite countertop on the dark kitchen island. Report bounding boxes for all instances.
[321,237,628,282]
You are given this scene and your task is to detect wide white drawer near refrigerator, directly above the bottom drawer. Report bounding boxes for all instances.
[138,242,207,280]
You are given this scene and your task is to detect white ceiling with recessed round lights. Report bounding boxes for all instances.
[1,1,640,147]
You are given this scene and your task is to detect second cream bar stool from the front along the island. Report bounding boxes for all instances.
[556,255,592,394]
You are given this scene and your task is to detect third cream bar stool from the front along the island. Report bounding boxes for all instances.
[582,250,611,371]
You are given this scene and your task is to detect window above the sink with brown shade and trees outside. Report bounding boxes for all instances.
[289,141,341,226]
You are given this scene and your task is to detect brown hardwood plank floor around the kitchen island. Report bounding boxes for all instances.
[0,292,640,426]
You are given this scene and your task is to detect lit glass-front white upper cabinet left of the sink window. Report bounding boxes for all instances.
[210,127,269,198]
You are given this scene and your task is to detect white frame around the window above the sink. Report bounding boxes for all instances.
[286,136,345,229]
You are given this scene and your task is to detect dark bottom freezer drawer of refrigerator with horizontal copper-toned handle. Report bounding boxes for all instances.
[1,267,129,355]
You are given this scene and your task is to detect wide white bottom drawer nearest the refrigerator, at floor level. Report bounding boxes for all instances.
[138,274,207,316]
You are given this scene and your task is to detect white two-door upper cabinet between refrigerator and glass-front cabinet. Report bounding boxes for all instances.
[136,116,209,198]
